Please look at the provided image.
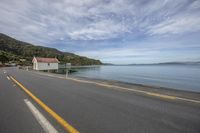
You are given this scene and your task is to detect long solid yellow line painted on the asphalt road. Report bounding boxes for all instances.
[10,76,79,133]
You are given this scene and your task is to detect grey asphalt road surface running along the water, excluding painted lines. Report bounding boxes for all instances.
[0,68,200,133]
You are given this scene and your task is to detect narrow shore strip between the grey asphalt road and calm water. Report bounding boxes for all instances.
[29,70,200,101]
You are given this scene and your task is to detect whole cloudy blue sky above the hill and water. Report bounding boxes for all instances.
[0,0,200,64]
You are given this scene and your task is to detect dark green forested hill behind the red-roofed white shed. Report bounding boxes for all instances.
[0,33,102,65]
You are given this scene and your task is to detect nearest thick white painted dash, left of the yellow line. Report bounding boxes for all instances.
[24,99,58,133]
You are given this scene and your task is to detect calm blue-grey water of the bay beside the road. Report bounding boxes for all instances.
[72,65,200,92]
